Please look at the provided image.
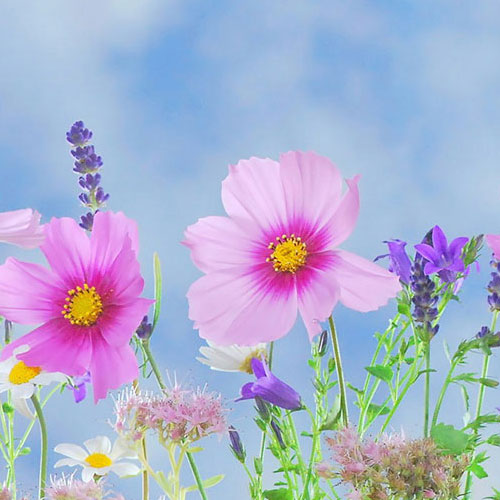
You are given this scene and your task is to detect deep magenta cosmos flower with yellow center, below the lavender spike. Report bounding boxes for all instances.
[0,212,152,401]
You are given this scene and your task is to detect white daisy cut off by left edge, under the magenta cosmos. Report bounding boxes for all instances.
[0,346,67,418]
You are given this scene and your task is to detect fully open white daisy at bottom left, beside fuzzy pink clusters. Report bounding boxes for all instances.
[54,436,141,483]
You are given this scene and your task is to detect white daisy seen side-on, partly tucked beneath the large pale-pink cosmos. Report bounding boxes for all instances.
[196,341,267,373]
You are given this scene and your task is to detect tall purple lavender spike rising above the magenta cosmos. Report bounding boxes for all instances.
[66,121,109,231]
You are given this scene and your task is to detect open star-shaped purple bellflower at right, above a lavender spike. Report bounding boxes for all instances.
[415,226,469,282]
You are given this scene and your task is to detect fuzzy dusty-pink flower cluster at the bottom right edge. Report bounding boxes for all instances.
[316,427,468,500]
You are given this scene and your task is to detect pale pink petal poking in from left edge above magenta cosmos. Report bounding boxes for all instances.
[0,208,44,248]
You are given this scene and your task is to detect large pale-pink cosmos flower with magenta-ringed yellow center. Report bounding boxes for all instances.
[184,152,400,345]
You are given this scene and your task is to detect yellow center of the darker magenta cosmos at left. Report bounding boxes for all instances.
[61,283,102,326]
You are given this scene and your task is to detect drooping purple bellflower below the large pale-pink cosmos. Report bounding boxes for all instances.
[236,358,302,410]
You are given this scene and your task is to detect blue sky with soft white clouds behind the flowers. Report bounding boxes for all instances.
[0,0,500,500]
